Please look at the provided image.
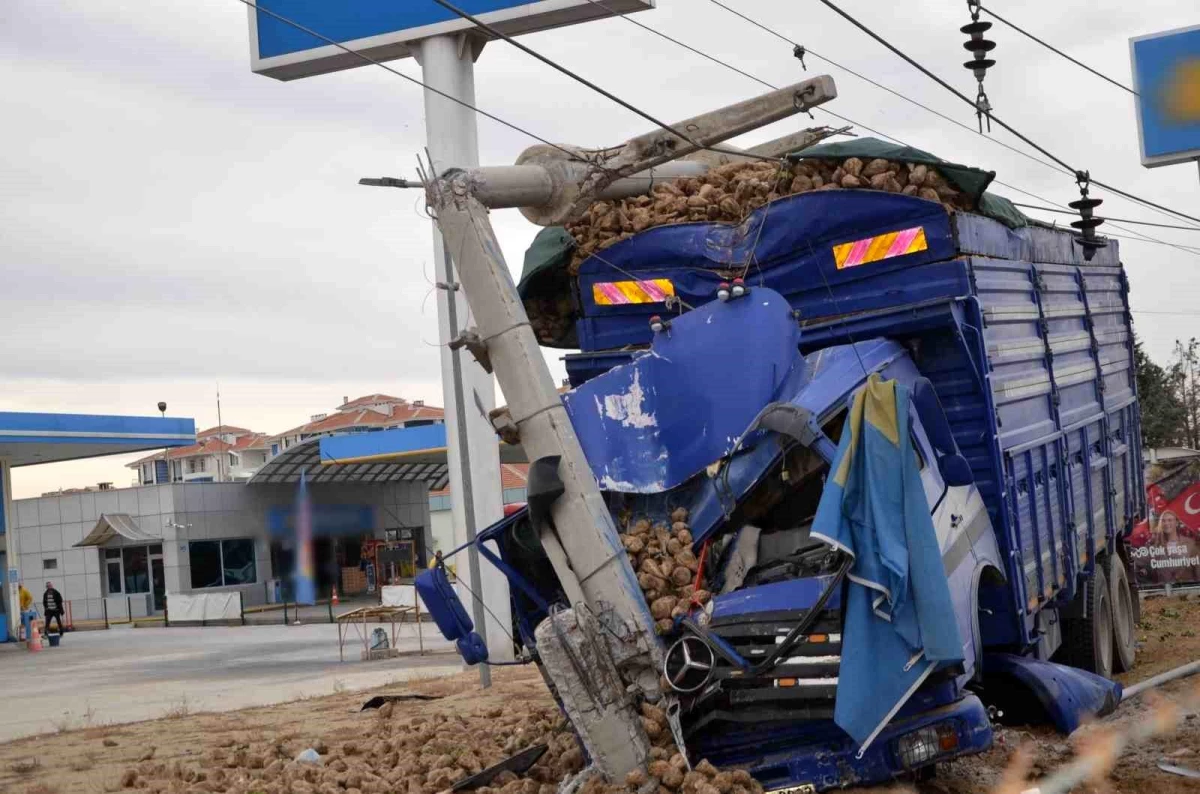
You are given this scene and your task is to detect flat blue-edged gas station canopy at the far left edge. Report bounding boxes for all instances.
[0,411,196,467]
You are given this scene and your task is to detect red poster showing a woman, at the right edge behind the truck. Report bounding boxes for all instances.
[1129,463,1200,588]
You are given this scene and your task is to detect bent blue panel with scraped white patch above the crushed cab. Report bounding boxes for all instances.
[563,289,808,493]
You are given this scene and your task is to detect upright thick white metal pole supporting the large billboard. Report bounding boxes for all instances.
[416,34,514,686]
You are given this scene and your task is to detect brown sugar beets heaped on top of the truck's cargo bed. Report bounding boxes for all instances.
[526,157,974,343]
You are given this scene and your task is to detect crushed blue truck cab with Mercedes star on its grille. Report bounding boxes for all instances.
[453,277,1002,788]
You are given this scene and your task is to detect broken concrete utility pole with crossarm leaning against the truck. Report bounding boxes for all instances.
[426,77,836,781]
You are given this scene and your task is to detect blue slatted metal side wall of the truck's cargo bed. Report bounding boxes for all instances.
[968,236,1140,615]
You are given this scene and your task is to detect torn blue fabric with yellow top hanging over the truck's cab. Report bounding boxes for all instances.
[812,374,962,753]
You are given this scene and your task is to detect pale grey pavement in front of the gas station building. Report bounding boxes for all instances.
[0,624,453,741]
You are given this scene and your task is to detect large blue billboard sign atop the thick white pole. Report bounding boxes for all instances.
[248,0,654,80]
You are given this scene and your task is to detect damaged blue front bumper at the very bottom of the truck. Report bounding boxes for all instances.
[703,694,992,792]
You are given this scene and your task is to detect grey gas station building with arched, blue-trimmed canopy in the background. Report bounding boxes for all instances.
[0,422,524,633]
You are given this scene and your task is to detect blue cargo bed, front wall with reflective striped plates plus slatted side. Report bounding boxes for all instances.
[566,191,1145,648]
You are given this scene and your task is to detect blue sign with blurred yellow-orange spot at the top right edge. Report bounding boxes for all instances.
[1129,25,1200,168]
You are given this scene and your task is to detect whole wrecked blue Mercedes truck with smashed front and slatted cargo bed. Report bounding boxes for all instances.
[419,91,1145,792]
